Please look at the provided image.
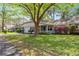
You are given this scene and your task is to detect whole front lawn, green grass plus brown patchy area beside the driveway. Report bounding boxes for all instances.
[6,35,79,56]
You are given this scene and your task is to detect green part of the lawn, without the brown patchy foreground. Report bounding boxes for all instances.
[6,35,79,56]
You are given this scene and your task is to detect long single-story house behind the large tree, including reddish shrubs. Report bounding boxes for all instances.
[9,16,79,33]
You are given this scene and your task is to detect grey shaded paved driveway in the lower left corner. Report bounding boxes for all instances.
[0,34,20,56]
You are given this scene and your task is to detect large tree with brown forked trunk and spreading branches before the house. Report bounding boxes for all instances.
[18,3,55,35]
